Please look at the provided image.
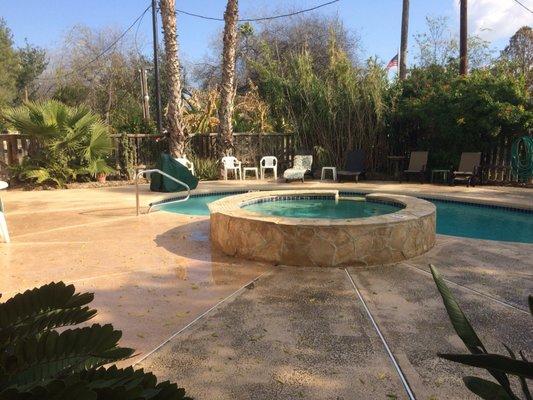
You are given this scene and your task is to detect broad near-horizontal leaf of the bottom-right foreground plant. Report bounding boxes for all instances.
[439,354,533,379]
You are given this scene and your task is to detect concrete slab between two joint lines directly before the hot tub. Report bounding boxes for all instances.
[140,267,406,400]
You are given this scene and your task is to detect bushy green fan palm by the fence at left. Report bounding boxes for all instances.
[2,100,113,186]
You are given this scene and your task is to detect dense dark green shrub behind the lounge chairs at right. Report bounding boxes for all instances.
[390,66,533,168]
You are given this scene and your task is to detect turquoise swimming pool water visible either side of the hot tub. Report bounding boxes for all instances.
[159,193,533,243]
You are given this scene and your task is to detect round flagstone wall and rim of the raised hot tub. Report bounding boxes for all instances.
[209,190,435,267]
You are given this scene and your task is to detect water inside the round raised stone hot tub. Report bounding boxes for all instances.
[244,199,400,219]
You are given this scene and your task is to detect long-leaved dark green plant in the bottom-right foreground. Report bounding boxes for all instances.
[430,265,533,400]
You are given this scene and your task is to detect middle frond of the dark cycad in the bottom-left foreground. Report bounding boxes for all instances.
[0,324,133,387]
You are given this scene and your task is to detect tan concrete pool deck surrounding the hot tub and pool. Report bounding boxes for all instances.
[0,181,533,399]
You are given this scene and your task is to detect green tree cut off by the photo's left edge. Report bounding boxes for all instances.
[0,18,18,107]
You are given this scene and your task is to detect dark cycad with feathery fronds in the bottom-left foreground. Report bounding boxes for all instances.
[0,282,189,400]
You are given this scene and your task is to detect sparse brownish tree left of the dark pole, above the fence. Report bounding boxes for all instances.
[44,25,146,130]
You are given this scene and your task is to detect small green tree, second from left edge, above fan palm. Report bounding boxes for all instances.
[17,41,48,102]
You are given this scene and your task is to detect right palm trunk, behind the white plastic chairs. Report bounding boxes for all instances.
[217,0,238,156]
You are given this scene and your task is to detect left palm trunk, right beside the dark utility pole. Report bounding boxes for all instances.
[159,0,187,157]
